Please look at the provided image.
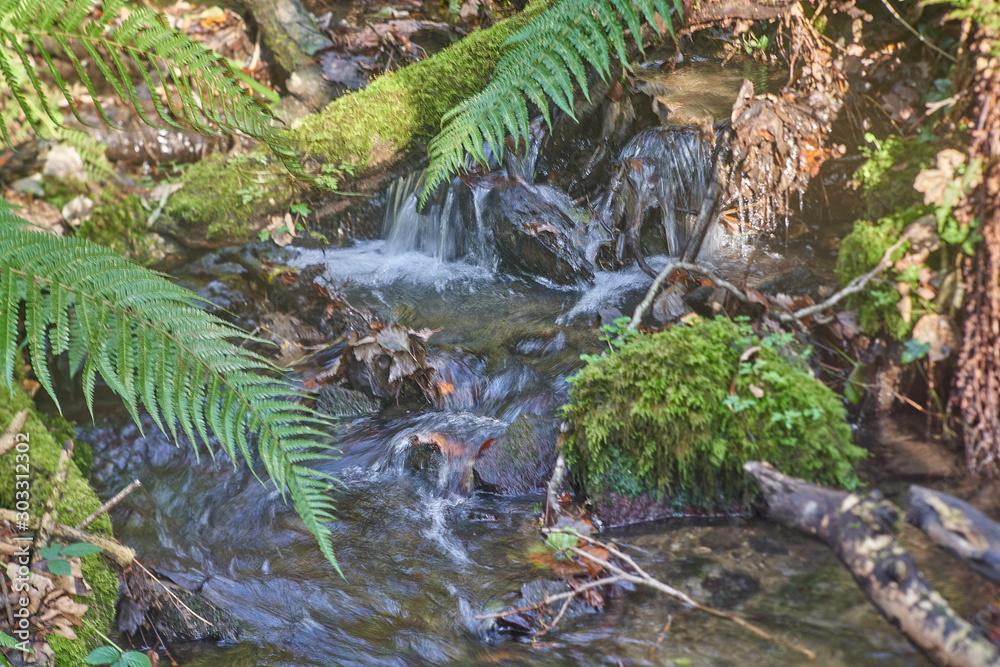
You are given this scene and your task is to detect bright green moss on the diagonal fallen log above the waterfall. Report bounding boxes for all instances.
[167,5,546,246]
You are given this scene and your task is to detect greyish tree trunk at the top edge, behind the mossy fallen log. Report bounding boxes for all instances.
[243,0,334,111]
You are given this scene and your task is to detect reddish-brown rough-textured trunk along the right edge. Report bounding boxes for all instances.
[949,36,1000,475]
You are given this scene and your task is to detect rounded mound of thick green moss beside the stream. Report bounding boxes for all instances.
[563,318,866,510]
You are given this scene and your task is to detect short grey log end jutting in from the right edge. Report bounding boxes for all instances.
[906,486,1000,584]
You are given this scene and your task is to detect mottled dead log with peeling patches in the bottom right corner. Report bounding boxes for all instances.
[744,461,1000,667]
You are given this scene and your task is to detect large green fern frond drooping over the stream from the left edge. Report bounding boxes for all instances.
[0,206,340,572]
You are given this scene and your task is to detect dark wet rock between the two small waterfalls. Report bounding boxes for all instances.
[483,183,594,285]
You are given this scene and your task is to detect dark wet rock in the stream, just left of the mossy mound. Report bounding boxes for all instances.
[473,414,559,495]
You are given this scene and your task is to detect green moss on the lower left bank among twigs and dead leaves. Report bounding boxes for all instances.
[0,388,118,667]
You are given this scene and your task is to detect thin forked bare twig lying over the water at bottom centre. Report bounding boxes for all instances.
[476,529,816,660]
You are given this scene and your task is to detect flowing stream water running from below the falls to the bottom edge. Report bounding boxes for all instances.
[68,60,960,667]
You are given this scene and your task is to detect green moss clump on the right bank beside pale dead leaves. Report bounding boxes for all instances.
[837,207,932,341]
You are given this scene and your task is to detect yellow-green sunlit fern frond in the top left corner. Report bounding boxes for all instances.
[0,0,303,175]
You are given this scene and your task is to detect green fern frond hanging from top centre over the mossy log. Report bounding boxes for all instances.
[420,0,680,205]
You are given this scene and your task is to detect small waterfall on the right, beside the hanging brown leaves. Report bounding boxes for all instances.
[597,126,712,256]
